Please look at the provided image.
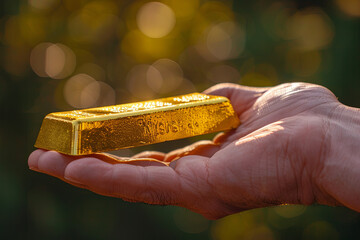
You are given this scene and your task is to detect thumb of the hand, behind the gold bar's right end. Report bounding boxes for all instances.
[204,83,269,115]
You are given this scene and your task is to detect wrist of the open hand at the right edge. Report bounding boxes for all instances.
[314,104,360,211]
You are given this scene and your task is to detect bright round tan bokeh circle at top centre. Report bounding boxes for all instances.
[136,2,176,38]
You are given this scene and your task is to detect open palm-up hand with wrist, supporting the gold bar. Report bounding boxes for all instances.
[29,83,360,219]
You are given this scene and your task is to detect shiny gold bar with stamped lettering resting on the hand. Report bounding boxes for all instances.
[35,93,239,155]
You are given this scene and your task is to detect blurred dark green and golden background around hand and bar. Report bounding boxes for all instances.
[0,0,360,239]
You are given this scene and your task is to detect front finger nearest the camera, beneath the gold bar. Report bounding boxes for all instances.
[64,158,181,204]
